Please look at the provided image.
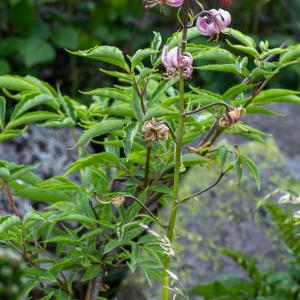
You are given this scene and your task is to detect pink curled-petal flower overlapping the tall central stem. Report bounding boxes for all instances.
[162,46,193,79]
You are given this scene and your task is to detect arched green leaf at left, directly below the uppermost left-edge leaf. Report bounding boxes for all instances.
[11,94,59,120]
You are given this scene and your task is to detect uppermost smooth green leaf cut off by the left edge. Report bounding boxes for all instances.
[0,75,38,92]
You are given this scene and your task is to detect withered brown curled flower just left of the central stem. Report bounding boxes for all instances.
[142,119,169,142]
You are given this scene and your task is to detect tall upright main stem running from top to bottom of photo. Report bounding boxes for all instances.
[163,0,189,300]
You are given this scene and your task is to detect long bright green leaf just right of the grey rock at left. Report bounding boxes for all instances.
[65,152,120,175]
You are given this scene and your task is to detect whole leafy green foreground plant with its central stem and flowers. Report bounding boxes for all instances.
[0,0,300,299]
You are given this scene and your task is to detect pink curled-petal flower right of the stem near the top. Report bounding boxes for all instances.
[196,9,231,36]
